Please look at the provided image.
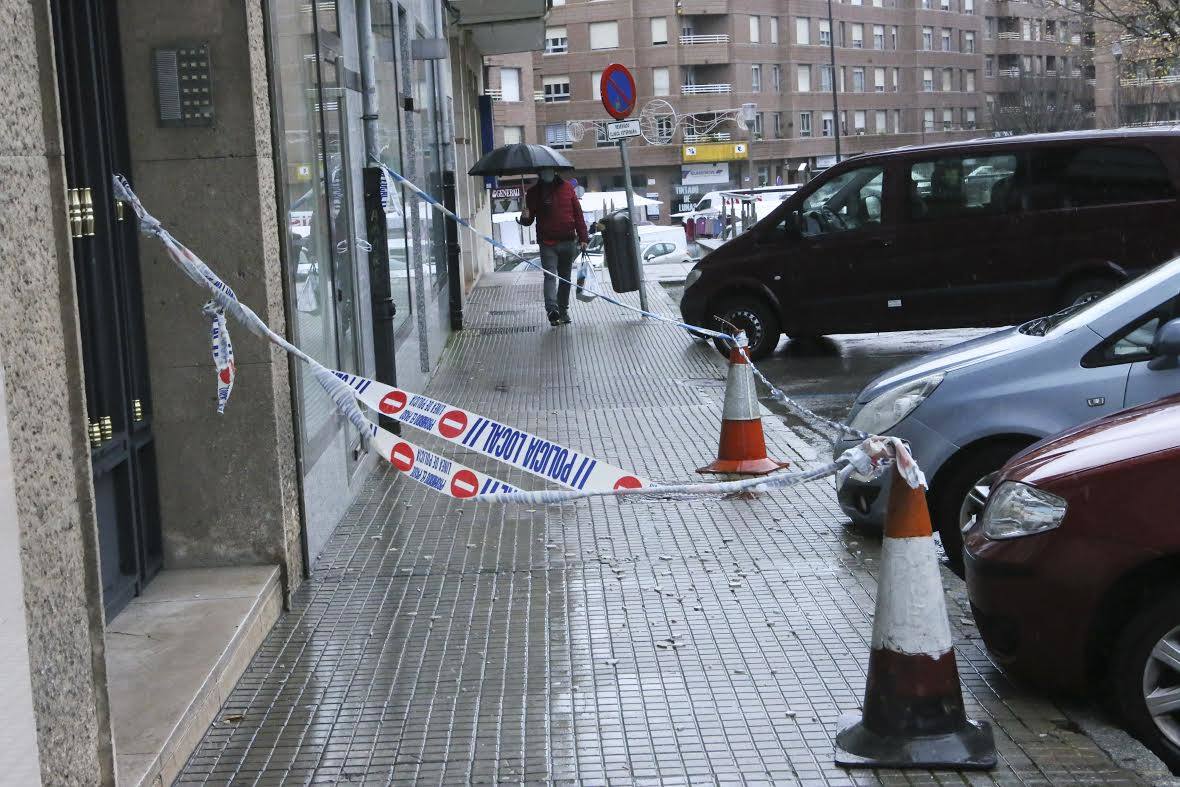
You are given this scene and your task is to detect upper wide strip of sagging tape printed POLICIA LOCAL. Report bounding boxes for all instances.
[334,372,649,491]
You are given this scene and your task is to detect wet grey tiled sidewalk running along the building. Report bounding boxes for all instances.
[179,274,1161,785]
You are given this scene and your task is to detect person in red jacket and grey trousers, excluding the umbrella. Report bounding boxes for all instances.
[517,166,590,326]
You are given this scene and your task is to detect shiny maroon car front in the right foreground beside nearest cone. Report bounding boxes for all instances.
[964,395,1180,770]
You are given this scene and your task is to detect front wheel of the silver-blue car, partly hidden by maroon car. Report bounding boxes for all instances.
[930,440,1029,577]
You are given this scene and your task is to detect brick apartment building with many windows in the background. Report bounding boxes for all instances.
[485,0,1094,223]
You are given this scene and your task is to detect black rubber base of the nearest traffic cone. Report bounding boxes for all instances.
[835,711,996,770]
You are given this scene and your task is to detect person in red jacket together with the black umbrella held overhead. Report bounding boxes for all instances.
[467,143,590,326]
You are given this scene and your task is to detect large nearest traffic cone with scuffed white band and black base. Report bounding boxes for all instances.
[835,468,996,768]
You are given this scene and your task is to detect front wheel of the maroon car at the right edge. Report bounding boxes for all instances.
[1110,590,1180,770]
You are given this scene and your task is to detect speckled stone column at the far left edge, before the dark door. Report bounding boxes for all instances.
[0,0,114,785]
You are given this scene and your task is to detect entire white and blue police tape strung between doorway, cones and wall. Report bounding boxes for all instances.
[113,169,925,504]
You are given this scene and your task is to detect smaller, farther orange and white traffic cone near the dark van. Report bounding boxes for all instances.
[696,333,787,476]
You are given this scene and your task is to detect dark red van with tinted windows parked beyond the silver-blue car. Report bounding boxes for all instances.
[681,129,1180,358]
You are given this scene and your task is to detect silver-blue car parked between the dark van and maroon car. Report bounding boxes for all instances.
[835,258,1180,569]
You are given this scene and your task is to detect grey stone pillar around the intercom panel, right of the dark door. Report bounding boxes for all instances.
[118,0,302,593]
